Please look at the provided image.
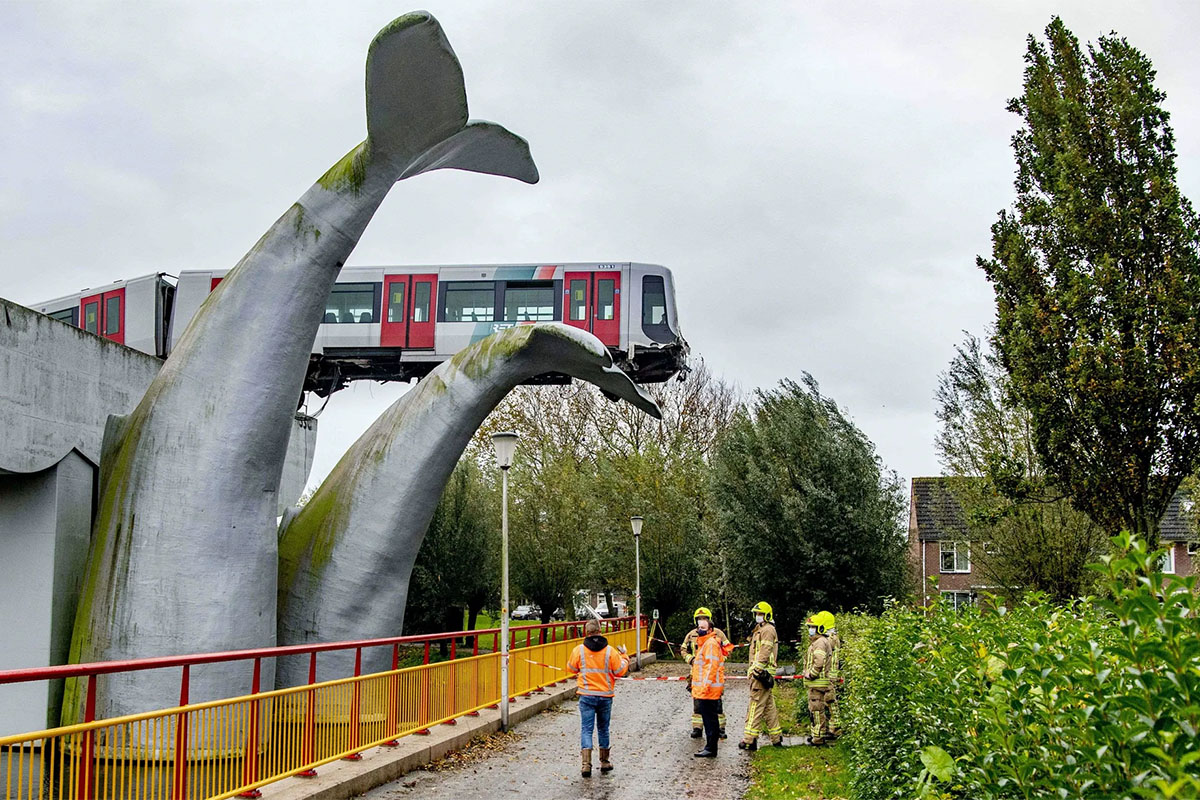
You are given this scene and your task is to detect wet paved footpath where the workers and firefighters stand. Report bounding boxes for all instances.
[362,663,750,800]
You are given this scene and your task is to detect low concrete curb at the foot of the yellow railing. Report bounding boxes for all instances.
[260,652,655,800]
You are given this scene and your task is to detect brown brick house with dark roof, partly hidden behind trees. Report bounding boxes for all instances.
[908,477,1200,607]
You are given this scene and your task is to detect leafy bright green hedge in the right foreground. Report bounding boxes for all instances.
[839,536,1200,800]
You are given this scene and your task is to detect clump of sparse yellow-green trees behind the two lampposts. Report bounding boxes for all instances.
[475,362,738,633]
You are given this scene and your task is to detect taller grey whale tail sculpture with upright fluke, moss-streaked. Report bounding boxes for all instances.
[64,12,538,723]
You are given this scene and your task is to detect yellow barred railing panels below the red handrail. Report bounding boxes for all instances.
[0,628,644,800]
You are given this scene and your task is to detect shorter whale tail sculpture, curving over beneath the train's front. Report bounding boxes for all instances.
[277,323,661,687]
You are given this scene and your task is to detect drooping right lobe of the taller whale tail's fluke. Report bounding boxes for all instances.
[401,120,538,184]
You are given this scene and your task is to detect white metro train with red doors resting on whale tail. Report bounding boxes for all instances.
[31,263,689,397]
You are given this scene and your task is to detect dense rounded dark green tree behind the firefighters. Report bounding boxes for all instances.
[712,375,910,630]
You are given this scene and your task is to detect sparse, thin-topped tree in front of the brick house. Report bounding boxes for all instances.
[935,335,1108,600]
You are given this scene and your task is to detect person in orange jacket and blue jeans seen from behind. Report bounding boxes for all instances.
[566,619,629,777]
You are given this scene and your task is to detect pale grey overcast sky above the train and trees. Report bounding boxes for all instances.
[0,0,1200,491]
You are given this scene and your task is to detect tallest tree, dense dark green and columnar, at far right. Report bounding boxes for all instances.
[978,17,1200,546]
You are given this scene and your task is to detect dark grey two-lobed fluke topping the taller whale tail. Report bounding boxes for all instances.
[366,11,538,184]
